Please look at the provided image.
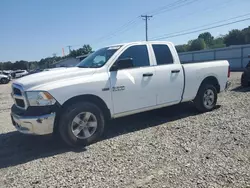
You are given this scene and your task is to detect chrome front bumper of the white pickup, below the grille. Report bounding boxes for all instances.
[11,113,56,135]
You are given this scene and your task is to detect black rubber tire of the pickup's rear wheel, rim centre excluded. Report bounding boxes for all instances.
[194,83,217,113]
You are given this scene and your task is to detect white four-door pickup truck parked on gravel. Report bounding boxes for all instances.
[11,42,230,146]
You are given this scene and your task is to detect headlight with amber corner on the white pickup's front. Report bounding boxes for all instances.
[26,91,56,106]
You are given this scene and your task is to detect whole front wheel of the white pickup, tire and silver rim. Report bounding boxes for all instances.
[59,102,105,147]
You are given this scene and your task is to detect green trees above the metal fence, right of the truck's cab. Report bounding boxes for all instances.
[176,26,250,52]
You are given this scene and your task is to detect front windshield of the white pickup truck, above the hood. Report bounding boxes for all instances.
[76,46,121,68]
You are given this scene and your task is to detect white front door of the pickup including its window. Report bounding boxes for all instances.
[110,45,156,114]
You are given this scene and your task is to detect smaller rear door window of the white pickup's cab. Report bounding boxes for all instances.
[152,44,174,65]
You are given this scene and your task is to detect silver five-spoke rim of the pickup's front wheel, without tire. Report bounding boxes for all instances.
[71,112,97,139]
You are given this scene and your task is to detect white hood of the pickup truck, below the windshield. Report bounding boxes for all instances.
[14,67,95,91]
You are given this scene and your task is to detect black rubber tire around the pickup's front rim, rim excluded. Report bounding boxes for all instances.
[58,102,105,147]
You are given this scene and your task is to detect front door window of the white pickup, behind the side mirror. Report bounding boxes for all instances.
[118,45,150,67]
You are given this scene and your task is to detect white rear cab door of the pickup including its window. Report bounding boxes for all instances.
[149,44,184,105]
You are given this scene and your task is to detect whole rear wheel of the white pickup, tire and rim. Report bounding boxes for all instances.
[194,84,217,112]
